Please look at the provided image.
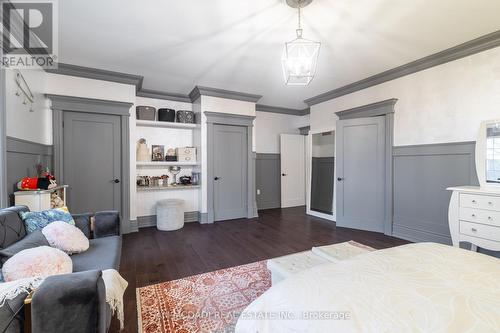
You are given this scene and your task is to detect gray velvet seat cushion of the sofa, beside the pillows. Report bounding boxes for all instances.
[71,236,122,272]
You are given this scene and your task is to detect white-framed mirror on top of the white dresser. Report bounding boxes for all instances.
[476,120,500,188]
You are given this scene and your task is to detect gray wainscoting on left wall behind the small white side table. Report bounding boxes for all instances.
[7,137,53,205]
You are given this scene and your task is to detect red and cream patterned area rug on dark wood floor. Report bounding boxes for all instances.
[137,260,271,333]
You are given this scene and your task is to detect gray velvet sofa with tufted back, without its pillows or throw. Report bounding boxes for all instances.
[0,206,122,333]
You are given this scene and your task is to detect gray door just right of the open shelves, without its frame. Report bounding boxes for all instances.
[214,125,248,221]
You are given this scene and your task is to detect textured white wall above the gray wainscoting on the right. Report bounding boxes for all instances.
[311,48,500,146]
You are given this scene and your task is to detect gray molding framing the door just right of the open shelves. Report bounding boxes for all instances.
[203,111,258,223]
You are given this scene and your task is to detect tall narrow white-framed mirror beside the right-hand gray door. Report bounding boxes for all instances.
[310,131,335,215]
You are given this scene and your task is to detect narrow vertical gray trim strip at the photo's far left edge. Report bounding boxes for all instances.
[0,68,9,208]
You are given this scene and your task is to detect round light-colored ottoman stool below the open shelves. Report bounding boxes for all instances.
[156,199,184,231]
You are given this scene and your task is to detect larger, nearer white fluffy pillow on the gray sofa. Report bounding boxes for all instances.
[2,246,73,282]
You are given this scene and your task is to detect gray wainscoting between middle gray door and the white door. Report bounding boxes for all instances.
[255,153,281,209]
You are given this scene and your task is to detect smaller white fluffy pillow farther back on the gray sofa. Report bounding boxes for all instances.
[42,221,89,254]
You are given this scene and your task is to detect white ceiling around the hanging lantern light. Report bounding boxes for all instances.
[59,0,500,108]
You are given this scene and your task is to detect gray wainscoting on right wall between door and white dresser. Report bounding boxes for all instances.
[393,142,479,244]
